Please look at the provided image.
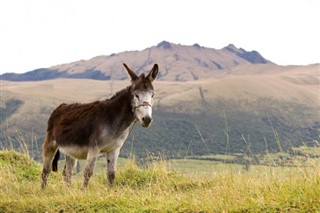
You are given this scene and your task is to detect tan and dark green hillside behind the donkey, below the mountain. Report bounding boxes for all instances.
[0,64,320,158]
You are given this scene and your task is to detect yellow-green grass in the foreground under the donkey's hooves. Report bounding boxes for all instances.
[0,151,320,212]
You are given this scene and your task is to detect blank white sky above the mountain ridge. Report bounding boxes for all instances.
[0,0,320,73]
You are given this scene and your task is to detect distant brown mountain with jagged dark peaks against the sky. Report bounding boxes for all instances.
[0,41,273,81]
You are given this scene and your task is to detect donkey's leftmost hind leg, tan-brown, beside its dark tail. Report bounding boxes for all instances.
[41,133,58,189]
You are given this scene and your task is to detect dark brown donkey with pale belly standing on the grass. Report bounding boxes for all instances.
[41,64,159,189]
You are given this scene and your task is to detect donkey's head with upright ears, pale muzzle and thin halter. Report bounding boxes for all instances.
[123,64,159,127]
